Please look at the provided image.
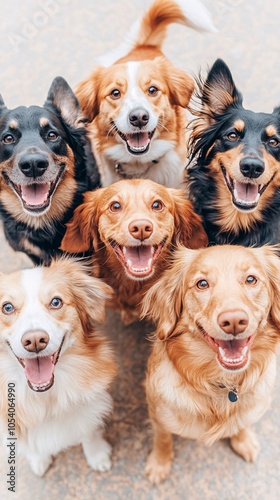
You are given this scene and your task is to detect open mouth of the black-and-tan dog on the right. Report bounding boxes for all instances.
[221,166,273,212]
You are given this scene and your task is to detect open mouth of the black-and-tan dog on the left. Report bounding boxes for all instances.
[3,168,64,214]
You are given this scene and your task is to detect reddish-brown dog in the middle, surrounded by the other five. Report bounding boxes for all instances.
[61,179,207,323]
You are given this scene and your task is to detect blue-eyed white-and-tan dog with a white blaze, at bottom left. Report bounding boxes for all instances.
[0,259,116,476]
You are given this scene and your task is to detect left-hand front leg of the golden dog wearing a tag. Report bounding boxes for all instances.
[145,422,174,484]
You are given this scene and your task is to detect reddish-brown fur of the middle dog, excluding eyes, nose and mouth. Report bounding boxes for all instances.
[61,179,207,322]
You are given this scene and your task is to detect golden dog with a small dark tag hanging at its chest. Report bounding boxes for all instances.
[143,245,280,483]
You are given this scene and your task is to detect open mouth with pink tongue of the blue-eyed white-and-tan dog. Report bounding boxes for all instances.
[11,338,64,392]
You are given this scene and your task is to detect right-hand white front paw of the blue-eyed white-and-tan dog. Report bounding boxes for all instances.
[83,438,112,472]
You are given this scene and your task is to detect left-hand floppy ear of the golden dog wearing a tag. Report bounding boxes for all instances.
[141,247,194,340]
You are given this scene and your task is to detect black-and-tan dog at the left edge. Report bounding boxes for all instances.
[0,77,99,264]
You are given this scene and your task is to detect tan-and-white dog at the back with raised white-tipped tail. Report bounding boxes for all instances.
[76,0,214,187]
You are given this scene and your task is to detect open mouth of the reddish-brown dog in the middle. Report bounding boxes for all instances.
[110,238,166,279]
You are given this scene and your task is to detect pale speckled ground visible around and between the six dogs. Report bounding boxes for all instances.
[0,0,280,500]
